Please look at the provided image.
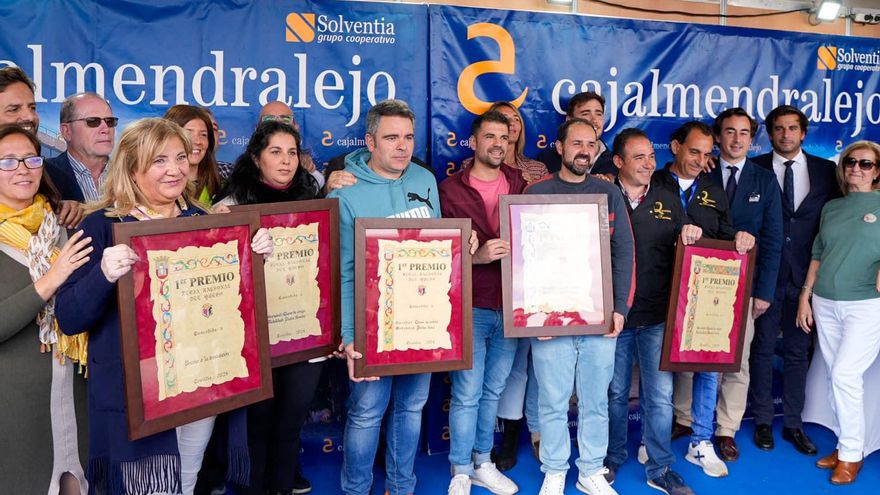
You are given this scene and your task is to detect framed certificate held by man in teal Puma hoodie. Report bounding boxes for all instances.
[354,218,473,377]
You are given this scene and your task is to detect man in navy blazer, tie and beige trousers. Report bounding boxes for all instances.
[675,108,783,461]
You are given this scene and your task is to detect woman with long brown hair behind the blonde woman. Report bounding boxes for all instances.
[164,105,222,206]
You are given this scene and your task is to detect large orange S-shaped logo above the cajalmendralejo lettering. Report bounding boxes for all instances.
[458,22,529,115]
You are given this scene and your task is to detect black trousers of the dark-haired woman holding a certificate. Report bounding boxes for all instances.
[243,362,324,495]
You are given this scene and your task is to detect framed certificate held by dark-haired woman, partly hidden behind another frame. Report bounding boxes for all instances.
[230,199,340,367]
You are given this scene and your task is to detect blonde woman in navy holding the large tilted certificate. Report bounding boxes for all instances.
[57,118,273,495]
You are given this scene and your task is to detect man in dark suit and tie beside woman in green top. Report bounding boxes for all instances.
[749,105,840,455]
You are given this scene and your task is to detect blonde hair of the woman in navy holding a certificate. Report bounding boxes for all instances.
[86,118,201,217]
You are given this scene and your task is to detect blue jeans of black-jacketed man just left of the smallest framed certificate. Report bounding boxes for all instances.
[607,323,675,480]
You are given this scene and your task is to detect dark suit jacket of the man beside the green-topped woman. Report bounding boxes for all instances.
[752,152,841,299]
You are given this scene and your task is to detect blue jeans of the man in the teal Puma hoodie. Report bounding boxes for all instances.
[341,373,431,495]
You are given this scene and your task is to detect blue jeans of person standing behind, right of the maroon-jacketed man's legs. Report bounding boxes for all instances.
[498,338,540,433]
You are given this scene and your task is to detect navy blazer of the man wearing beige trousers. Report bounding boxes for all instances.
[710,159,783,302]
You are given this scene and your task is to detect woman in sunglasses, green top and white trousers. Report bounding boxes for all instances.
[797,141,880,485]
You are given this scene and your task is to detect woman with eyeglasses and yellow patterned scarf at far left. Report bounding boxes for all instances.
[0,124,92,495]
